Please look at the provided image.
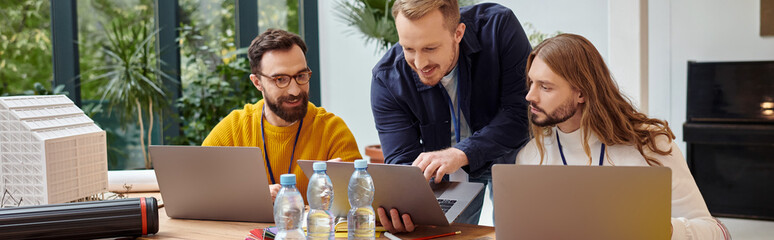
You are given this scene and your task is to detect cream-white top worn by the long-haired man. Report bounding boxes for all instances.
[516,127,725,239]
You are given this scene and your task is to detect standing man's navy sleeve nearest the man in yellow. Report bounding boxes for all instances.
[371,72,423,165]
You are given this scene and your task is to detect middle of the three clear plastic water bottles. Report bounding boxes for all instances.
[306,162,334,240]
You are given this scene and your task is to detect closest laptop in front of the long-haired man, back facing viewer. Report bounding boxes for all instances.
[492,164,672,239]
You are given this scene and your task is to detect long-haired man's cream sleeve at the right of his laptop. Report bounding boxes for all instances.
[657,138,729,240]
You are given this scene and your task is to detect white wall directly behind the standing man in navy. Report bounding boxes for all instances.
[315,0,608,157]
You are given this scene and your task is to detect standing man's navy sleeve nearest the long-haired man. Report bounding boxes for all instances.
[454,10,532,173]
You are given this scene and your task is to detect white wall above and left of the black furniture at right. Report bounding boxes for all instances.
[650,0,774,149]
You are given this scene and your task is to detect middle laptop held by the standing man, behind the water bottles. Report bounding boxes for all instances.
[298,160,484,226]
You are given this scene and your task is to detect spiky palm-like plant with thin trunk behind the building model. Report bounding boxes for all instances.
[90,20,175,168]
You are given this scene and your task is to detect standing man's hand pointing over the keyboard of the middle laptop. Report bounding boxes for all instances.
[411,148,468,183]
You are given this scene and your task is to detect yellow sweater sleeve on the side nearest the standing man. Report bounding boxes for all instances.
[326,116,363,162]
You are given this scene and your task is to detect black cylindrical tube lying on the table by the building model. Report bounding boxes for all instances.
[0,197,159,239]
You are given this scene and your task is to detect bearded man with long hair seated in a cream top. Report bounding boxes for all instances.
[516,34,728,239]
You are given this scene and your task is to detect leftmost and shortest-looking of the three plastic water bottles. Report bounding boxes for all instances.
[274,174,305,240]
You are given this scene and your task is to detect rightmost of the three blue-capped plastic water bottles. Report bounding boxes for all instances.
[347,160,376,240]
